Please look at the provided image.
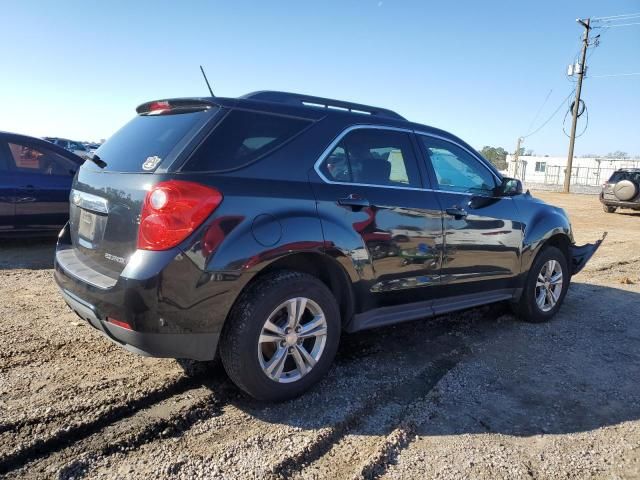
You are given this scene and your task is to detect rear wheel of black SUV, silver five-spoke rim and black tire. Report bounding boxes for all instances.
[220,271,341,401]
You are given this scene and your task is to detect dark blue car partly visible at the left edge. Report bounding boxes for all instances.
[0,132,84,236]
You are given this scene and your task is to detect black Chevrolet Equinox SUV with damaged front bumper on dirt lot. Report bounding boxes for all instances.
[55,92,600,400]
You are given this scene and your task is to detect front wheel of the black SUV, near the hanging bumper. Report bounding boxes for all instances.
[514,246,570,323]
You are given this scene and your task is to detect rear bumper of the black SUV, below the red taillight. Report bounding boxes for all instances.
[54,221,243,360]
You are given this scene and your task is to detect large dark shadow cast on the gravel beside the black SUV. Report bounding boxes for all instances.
[224,283,640,441]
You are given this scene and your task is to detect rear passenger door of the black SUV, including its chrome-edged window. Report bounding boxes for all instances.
[312,126,442,310]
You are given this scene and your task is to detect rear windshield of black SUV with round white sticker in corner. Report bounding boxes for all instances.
[89,109,217,172]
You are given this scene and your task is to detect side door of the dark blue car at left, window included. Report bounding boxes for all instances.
[8,140,79,230]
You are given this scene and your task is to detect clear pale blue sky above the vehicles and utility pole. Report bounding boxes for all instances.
[0,0,640,155]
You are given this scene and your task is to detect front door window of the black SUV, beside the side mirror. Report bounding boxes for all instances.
[420,135,497,193]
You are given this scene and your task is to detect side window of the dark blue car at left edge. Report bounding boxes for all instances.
[8,142,78,177]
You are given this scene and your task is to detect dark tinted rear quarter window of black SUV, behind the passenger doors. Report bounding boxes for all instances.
[182,110,310,172]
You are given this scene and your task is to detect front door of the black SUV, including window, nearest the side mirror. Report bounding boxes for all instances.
[417,134,523,296]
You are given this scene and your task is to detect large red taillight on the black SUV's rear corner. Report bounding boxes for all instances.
[138,180,222,250]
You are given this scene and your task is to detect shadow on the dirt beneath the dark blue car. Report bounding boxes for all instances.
[0,235,58,270]
